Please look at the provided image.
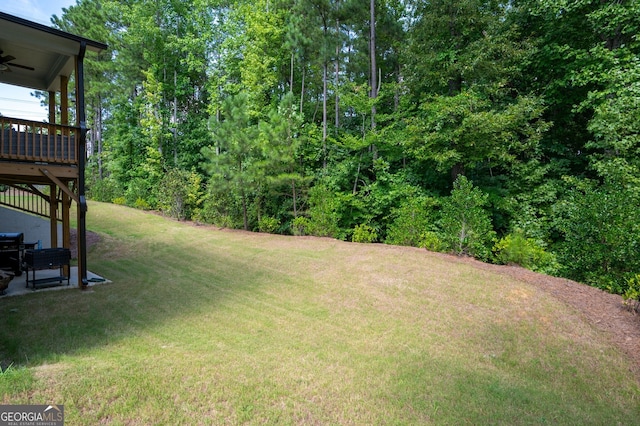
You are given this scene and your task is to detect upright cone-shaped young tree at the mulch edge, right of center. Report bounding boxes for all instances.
[440,175,495,260]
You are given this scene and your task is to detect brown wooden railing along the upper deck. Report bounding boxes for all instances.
[0,116,79,165]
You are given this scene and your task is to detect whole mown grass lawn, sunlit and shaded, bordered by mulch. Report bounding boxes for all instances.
[0,203,640,425]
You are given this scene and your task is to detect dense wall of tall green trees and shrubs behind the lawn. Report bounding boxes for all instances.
[53,0,640,293]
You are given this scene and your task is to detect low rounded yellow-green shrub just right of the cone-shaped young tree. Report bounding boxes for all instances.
[493,230,559,275]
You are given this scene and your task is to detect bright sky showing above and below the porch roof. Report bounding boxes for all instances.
[0,0,76,121]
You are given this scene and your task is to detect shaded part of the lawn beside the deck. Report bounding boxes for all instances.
[0,221,265,365]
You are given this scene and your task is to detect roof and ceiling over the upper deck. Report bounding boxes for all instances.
[0,12,107,91]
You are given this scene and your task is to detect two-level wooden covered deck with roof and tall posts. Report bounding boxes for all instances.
[0,12,107,293]
